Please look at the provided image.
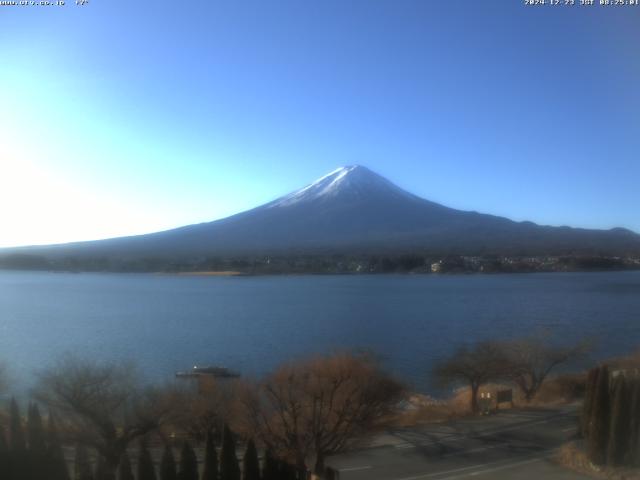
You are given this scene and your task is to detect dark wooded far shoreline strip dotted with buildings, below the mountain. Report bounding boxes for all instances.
[0,252,640,275]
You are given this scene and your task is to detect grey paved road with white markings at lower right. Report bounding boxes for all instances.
[327,407,589,480]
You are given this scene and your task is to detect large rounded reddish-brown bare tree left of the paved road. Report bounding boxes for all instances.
[238,354,403,472]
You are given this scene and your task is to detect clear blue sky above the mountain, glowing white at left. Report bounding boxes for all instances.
[0,0,640,246]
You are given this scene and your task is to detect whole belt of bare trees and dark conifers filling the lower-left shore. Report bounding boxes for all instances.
[0,353,403,480]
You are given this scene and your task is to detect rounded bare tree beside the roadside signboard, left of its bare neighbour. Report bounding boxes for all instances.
[434,342,507,413]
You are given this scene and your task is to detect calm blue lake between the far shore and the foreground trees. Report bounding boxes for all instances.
[0,271,640,391]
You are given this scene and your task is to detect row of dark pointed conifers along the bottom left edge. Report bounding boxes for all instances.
[0,399,296,480]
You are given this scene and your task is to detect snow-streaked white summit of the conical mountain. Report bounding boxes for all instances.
[266,165,413,208]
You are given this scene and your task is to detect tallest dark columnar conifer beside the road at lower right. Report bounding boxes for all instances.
[587,365,610,465]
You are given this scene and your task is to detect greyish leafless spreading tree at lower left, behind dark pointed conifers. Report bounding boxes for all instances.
[36,357,172,478]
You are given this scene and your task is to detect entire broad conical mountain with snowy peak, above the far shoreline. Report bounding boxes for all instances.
[0,166,640,260]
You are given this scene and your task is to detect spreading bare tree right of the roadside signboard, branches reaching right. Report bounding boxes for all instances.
[500,333,591,402]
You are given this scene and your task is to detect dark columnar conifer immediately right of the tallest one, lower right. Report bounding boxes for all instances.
[607,376,631,467]
